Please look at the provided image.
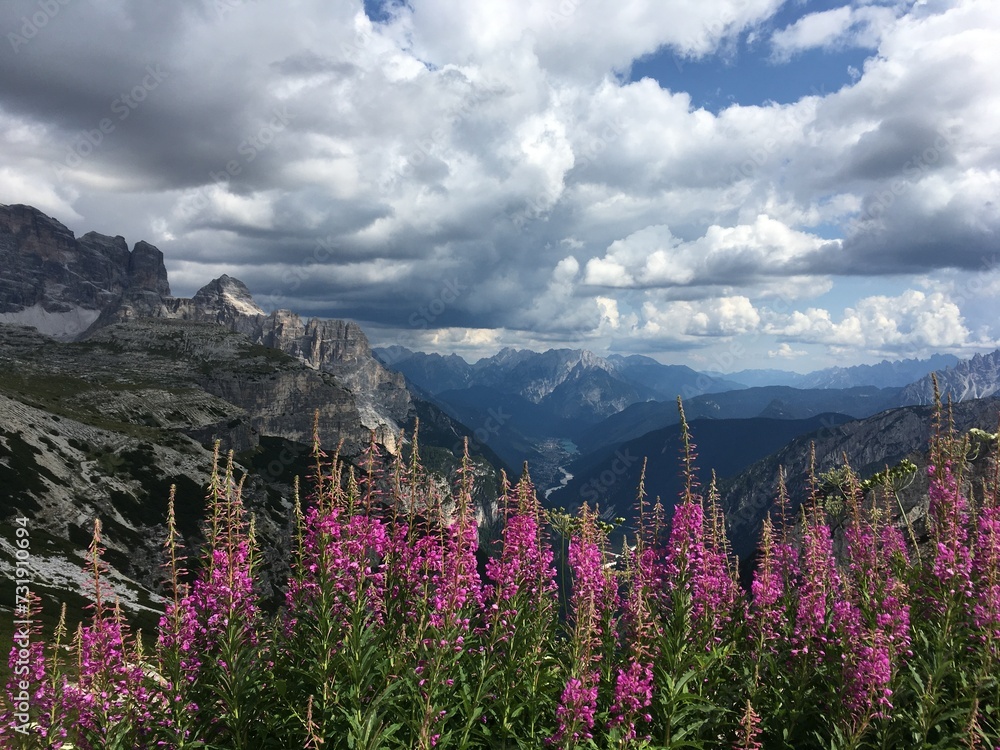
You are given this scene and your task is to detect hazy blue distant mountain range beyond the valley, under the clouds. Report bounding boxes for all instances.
[375,346,1000,502]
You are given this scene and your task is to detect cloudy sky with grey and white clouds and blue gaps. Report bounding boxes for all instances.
[0,0,1000,371]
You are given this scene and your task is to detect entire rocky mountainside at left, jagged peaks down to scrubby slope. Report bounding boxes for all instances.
[0,206,497,628]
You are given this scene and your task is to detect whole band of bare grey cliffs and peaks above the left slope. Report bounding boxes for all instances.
[0,205,413,444]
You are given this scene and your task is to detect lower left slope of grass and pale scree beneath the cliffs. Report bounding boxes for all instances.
[0,318,497,624]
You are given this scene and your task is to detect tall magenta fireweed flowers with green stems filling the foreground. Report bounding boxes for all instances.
[0,396,1000,750]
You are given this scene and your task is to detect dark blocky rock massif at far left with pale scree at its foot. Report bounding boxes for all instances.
[0,205,170,340]
